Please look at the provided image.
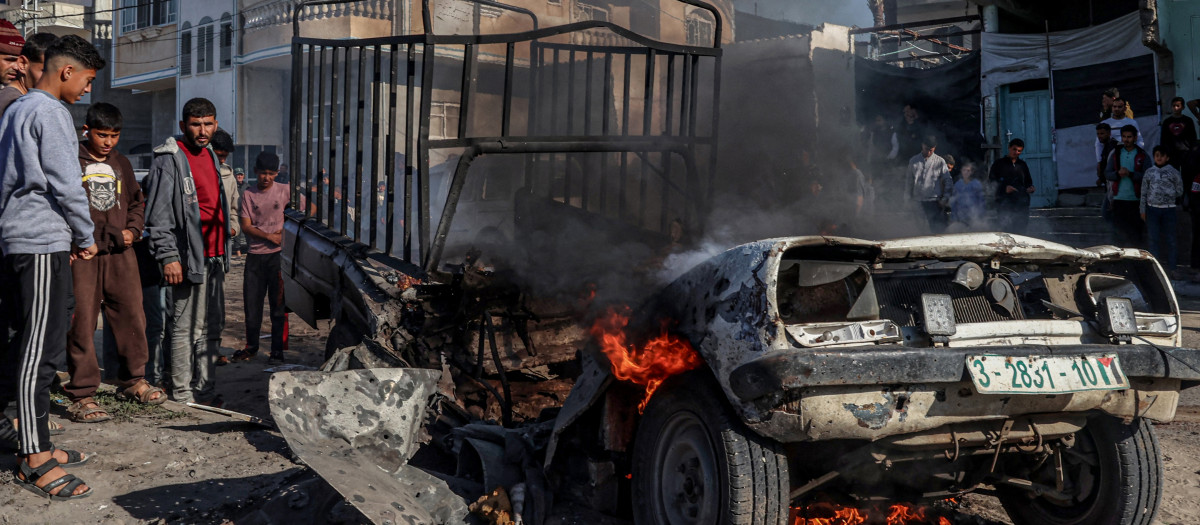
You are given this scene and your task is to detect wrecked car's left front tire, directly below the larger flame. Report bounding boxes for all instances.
[632,373,791,525]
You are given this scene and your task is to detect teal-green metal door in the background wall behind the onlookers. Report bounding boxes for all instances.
[1000,86,1058,207]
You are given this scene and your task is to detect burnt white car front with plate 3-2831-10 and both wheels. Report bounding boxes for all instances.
[580,234,1200,524]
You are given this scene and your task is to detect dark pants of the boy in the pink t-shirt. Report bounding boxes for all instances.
[241,252,288,357]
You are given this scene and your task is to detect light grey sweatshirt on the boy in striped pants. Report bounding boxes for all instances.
[0,90,95,254]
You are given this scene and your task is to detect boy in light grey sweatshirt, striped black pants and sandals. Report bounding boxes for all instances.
[0,35,104,500]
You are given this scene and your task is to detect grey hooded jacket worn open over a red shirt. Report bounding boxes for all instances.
[143,137,239,284]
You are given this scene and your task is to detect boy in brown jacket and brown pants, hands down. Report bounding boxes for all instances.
[64,102,167,423]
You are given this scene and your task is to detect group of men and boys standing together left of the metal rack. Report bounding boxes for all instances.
[0,20,289,500]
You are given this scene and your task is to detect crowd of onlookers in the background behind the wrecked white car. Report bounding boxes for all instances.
[797,88,1200,280]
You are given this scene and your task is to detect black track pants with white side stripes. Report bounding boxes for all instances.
[0,252,74,454]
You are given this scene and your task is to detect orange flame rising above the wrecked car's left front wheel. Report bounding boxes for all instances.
[590,308,701,414]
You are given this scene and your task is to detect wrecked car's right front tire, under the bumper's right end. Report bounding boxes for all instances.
[1000,416,1163,525]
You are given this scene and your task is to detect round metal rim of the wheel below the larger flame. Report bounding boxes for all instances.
[650,411,720,525]
